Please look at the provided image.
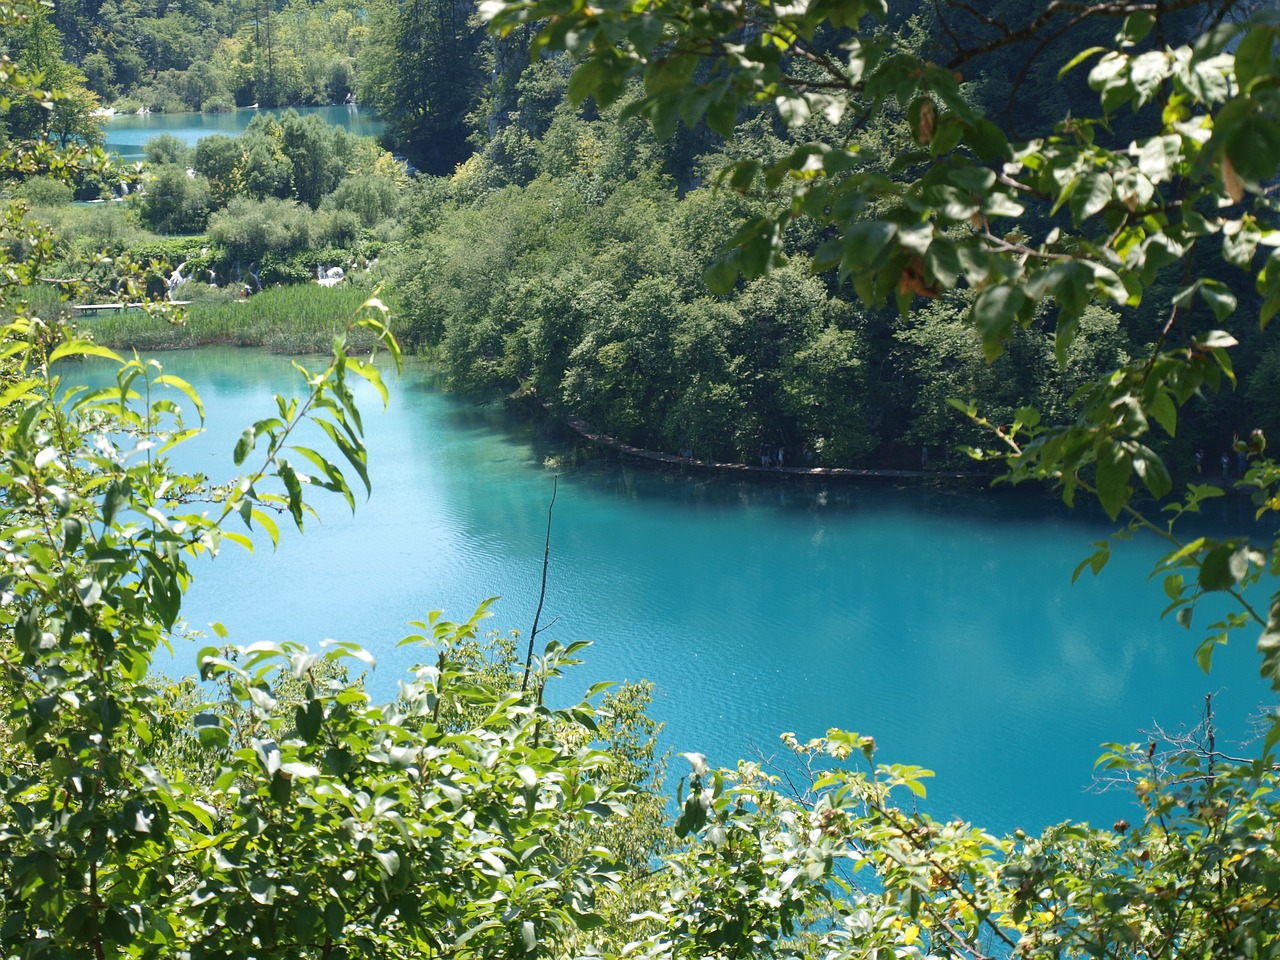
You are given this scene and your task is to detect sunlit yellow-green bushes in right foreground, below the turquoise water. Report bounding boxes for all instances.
[622,731,1280,960]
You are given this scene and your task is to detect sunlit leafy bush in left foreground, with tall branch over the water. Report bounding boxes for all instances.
[0,304,660,957]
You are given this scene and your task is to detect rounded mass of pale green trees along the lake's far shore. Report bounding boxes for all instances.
[397,175,874,465]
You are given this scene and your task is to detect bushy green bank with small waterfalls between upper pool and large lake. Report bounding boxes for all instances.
[13,111,408,352]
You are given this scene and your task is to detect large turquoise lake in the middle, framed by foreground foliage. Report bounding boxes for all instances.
[82,349,1267,829]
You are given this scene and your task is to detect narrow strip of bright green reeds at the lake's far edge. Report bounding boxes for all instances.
[82,284,389,353]
